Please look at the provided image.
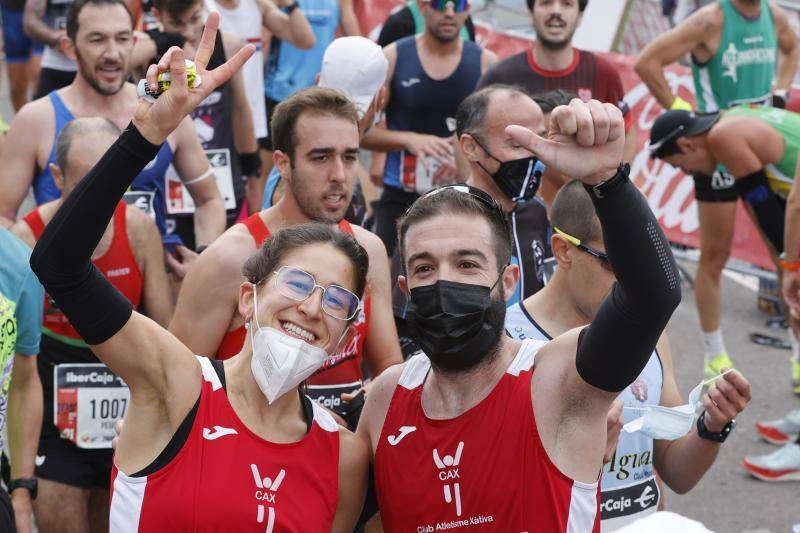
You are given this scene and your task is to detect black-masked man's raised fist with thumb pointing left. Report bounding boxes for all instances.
[506,98,625,185]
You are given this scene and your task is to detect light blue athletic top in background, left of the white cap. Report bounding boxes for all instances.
[264,0,339,102]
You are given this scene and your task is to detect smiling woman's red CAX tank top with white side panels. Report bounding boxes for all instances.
[109,357,339,533]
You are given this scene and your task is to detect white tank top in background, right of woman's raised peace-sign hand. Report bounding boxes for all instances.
[206,0,267,139]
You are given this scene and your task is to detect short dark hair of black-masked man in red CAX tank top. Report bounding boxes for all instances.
[397,188,512,272]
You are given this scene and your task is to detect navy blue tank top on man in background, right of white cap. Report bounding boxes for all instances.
[383,36,482,191]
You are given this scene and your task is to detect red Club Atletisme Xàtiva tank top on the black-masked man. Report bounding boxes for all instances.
[375,341,600,533]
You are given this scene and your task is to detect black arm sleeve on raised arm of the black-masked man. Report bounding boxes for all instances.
[575,170,681,392]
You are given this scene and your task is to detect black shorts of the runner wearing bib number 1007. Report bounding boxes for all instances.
[36,435,114,490]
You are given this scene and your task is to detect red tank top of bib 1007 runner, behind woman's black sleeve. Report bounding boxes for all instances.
[23,202,144,346]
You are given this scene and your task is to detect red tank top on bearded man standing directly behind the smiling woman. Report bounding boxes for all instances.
[217,213,371,410]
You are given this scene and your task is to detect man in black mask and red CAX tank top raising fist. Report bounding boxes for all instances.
[357,100,680,532]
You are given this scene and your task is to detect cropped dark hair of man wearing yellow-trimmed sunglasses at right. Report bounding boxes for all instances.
[550,180,603,242]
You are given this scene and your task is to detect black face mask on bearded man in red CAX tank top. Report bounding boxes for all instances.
[406,278,506,372]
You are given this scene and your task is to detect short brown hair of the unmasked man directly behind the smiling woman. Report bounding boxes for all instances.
[270,87,358,160]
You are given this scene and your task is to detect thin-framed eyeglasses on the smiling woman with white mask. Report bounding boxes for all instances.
[274,266,361,320]
